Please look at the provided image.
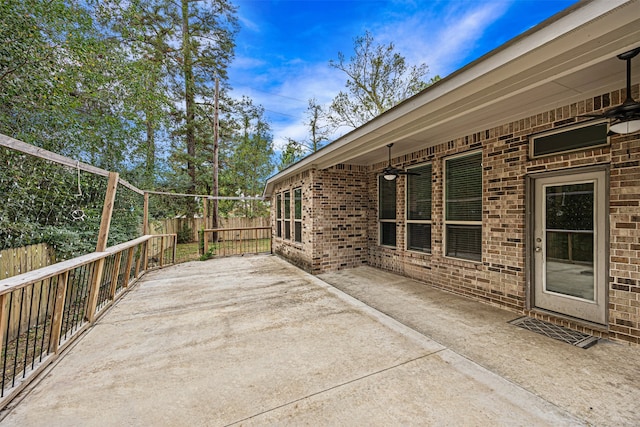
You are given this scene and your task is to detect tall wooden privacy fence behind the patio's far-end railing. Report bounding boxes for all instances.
[151,217,271,243]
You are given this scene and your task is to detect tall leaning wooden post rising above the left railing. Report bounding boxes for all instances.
[86,172,118,322]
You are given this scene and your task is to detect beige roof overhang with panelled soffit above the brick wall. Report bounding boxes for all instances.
[264,0,640,197]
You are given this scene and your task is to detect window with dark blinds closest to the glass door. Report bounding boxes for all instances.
[444,152,482,261]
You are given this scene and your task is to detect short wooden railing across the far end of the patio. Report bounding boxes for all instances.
[202,227,271,256]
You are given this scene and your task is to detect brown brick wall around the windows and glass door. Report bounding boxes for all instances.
[274,85,640,343]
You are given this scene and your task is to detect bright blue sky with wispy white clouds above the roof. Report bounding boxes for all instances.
[229,0,577,150]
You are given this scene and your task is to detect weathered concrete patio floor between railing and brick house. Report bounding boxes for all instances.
[1,256,640,426]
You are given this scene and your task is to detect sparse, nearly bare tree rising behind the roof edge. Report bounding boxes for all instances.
[329,31,440,128]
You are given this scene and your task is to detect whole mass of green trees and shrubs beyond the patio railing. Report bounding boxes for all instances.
[0,0,273,259]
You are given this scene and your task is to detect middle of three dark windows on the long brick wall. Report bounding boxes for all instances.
[406,165,431,252]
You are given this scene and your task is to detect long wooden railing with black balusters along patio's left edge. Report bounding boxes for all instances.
[0,234,177,408]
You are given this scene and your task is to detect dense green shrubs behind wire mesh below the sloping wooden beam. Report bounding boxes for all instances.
[0,148,142,260]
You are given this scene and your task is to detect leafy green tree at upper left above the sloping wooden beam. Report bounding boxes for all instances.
[0,0,139,169]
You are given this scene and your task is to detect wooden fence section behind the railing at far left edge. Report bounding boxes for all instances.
[0,243,55,279]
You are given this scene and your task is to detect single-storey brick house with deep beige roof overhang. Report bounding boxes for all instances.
[265,1,640,343]
